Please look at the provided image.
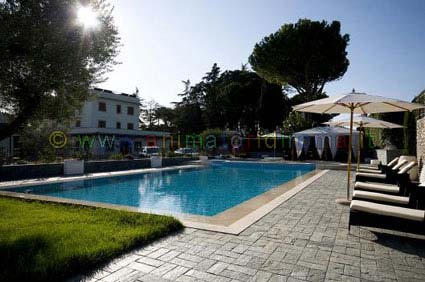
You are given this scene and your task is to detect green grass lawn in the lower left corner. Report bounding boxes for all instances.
[0,197,182,281]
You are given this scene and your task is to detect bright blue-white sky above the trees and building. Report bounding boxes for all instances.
[100,0,425,105]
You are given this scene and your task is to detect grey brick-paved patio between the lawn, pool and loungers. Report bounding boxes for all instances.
[78,171,425,282]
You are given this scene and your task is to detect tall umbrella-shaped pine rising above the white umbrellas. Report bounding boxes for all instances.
[249,19,350,102]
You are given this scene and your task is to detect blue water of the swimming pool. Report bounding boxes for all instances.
[7,161,315,216]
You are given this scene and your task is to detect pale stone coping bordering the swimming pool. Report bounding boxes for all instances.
[0,165,329,235]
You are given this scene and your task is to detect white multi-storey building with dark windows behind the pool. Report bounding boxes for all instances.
[69,88,169,156]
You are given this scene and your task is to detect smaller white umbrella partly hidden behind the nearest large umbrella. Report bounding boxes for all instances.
[324,115,403,170]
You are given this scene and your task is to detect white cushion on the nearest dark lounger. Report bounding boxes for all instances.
[350,200,425,222]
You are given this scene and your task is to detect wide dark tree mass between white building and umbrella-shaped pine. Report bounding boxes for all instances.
[151,64,290,134]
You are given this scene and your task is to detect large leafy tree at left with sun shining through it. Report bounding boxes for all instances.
[0,0,120,140]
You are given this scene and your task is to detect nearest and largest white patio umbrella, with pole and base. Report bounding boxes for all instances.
[293,89,425,203]
